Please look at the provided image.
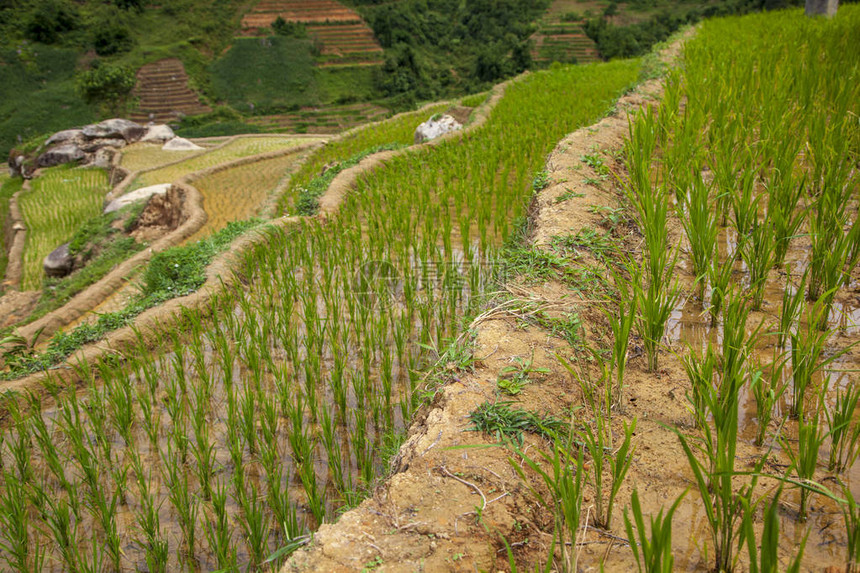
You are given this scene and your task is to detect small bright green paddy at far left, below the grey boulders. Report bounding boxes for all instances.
[19,166,110,290]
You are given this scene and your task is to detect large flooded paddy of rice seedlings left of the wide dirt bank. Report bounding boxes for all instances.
[0,57,638,570]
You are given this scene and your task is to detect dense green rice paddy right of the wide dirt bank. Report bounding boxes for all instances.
[613,6,860,571]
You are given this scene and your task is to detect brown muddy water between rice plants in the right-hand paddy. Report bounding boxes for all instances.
[666,220,860,571]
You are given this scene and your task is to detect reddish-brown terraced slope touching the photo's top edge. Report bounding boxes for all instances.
[242,0,382,65]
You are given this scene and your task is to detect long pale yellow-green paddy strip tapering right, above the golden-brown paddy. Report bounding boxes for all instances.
[132,136,314,189]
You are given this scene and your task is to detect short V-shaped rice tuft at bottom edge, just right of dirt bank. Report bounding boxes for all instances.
[624,489,686,573]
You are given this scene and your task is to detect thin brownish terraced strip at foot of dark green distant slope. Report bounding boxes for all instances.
[248,103,388,133]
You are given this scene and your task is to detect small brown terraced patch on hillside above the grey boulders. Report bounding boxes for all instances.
[131,58,212,123]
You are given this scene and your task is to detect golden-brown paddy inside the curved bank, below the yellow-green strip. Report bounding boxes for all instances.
[186,153,301,243]
